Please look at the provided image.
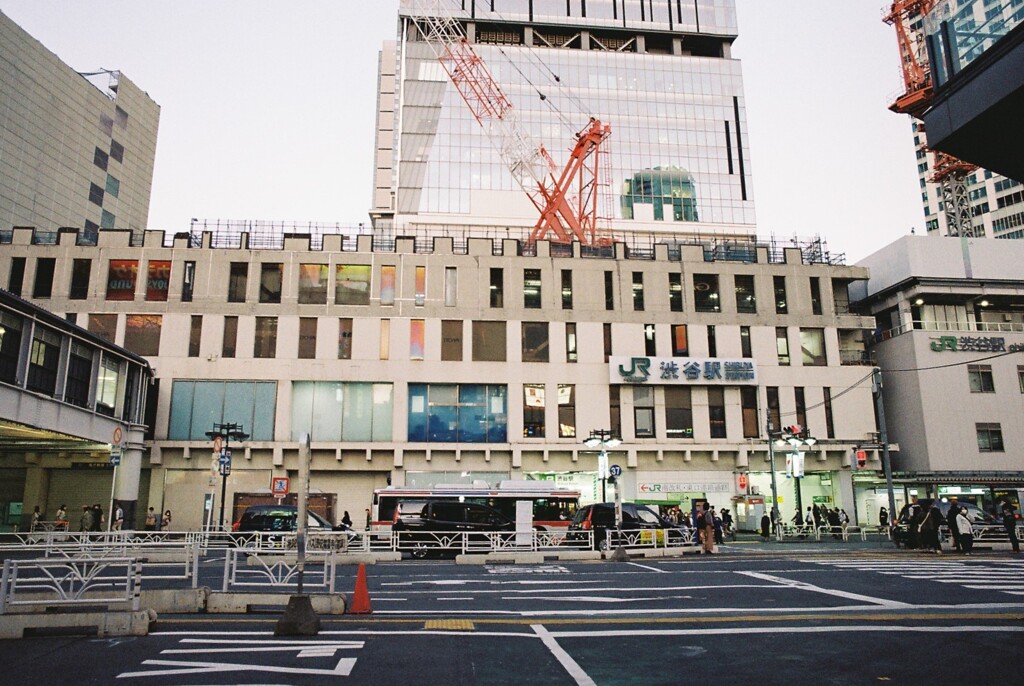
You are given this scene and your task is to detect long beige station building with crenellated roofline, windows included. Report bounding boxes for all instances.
[0,229,880,527]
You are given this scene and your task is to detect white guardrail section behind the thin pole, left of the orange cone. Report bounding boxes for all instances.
[221,548,337,593]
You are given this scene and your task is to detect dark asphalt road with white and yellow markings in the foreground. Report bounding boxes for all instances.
[0,545,1024,686]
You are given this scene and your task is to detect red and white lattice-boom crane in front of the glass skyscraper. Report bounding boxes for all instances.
[403,0,611,246]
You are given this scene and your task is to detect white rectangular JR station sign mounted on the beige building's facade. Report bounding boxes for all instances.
[608,357,758,386]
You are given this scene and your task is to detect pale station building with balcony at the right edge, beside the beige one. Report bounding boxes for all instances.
[851,235,1024,516]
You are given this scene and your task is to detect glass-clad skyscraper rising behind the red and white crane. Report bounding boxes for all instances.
[372,0,755,234]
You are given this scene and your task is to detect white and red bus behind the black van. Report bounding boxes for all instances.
[373,480,580,532]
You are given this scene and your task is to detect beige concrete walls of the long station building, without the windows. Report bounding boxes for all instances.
[0,230,879,528]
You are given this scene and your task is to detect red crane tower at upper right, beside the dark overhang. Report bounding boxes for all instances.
[882,0,978,237]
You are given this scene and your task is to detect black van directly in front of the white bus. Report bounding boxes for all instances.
[391,501,515,558]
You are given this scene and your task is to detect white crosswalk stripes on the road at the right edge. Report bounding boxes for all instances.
[803,557,1024,596]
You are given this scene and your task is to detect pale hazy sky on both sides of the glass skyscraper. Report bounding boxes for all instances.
[0,0,925,263]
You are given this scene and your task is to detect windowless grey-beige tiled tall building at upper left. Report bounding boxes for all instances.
[0,12,160,240]
